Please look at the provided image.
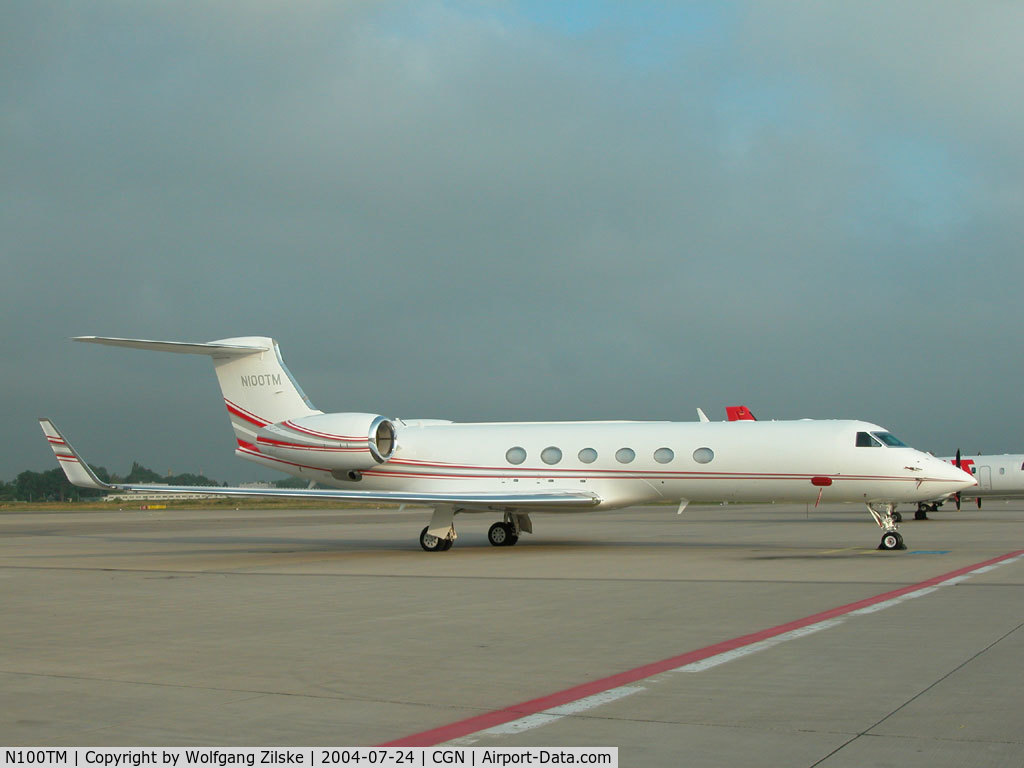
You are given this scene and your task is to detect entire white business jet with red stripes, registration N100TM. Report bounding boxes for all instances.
[40,336,977,552]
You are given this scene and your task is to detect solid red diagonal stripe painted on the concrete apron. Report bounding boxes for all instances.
[377,550,1024,746]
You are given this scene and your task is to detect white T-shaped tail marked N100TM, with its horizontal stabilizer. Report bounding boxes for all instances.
[75,336,321,442]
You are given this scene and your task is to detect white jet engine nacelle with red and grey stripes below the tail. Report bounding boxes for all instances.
[256,414,395,480]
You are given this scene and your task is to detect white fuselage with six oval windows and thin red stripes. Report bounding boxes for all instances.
[238,414,964,509]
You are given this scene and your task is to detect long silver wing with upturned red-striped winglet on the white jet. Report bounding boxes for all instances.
[39,419,601,509]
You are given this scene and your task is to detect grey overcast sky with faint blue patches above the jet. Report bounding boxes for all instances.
[0,0,1024,482]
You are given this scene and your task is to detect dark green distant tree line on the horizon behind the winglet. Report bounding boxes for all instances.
[0,462,307,502]
